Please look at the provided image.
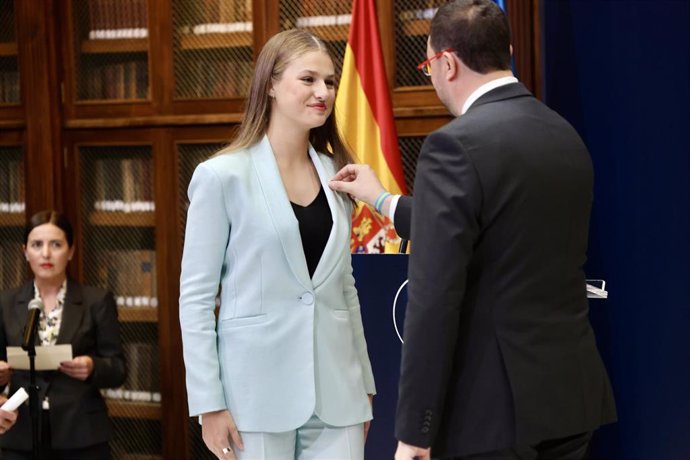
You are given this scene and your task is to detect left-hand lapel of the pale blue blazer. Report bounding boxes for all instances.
[251,136,313,290]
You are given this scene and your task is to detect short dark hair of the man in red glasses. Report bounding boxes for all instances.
[429,0,510,74]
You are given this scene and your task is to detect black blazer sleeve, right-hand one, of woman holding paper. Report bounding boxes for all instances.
[90,291,126,388]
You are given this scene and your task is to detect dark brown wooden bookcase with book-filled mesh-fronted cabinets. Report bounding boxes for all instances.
[0,0,541,460]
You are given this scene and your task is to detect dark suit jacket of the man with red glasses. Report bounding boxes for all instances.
[395,84,616,457]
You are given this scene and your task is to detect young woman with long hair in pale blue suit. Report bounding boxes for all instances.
[180,30,375,460]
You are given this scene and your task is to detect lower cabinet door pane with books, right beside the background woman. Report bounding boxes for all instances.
[79,146,161,459]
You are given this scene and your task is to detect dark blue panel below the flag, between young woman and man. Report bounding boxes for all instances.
[352,254,407,459]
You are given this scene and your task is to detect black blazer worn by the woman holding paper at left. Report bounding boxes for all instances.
[0,280,125,450]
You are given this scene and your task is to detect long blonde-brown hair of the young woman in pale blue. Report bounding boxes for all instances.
[217,29,353,169]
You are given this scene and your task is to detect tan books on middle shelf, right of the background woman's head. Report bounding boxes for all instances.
[92,249,158,300]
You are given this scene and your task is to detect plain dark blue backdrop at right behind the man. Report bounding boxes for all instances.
[541,0,690,460]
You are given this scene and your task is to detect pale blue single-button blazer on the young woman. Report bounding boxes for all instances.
[180,137,375,432]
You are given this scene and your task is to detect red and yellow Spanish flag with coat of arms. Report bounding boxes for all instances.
[335,0,407,253]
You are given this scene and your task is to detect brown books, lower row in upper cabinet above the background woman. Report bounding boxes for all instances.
[79,59,149,100]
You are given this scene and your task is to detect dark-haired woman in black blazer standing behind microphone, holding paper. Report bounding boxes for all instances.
[0,211,125,460]
